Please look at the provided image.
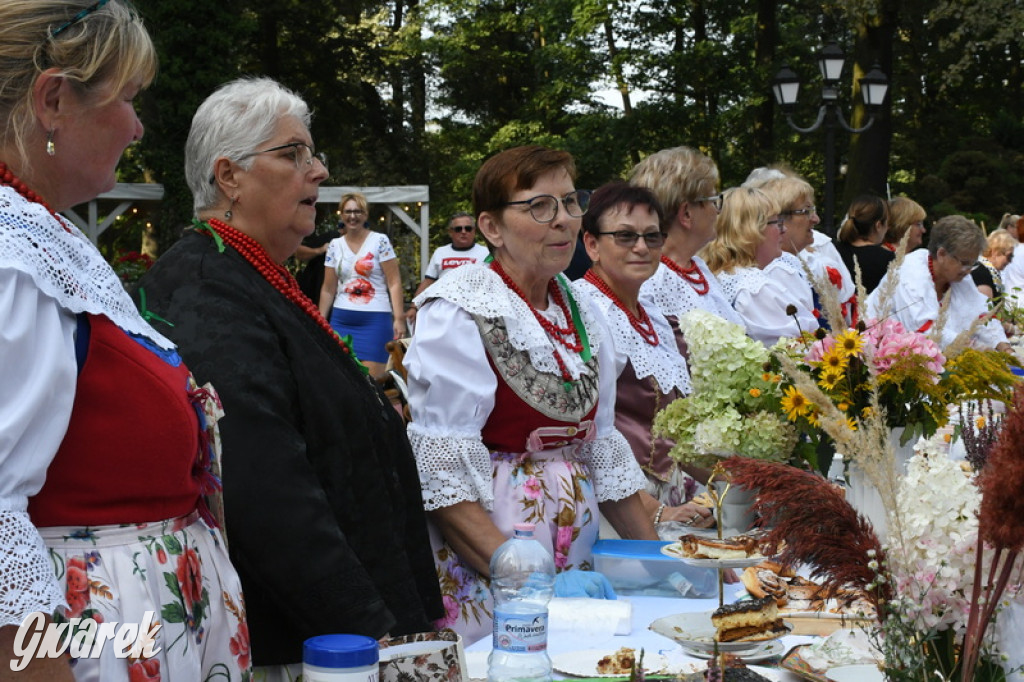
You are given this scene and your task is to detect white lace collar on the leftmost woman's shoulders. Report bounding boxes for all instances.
[0,185,174,350]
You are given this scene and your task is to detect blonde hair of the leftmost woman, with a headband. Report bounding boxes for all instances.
[0,0,157,165]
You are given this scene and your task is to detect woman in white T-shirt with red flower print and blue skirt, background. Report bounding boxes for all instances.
[319,193,407,378]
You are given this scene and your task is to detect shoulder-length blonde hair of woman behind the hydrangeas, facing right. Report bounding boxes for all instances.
[700,187,778,274]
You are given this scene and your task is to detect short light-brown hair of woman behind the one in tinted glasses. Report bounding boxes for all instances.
[630,146,719,231]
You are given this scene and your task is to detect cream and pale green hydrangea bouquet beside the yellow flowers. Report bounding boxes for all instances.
[653,310,797,466]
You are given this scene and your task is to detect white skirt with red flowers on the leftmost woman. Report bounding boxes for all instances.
[40,512,251,682]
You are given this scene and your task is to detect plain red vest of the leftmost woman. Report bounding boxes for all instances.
[29,315,200,527]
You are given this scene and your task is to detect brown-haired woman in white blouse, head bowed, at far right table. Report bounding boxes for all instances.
[865,215,1011,352]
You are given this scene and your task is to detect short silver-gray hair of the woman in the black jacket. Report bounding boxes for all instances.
[185,77,312,215]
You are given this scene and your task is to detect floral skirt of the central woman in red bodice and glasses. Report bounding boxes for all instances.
[430,446,599,645]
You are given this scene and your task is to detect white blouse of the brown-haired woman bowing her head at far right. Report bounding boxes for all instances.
[865,249,1007,348]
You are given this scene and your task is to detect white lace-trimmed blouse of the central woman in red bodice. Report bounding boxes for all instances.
[403,265,645,510]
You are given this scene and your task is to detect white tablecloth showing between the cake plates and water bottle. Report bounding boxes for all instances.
[466,584,815,682]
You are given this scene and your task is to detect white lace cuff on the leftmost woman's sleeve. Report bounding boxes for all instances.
[0,511,68,628]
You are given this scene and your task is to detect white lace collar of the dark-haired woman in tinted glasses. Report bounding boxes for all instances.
[572,280,691,394]
